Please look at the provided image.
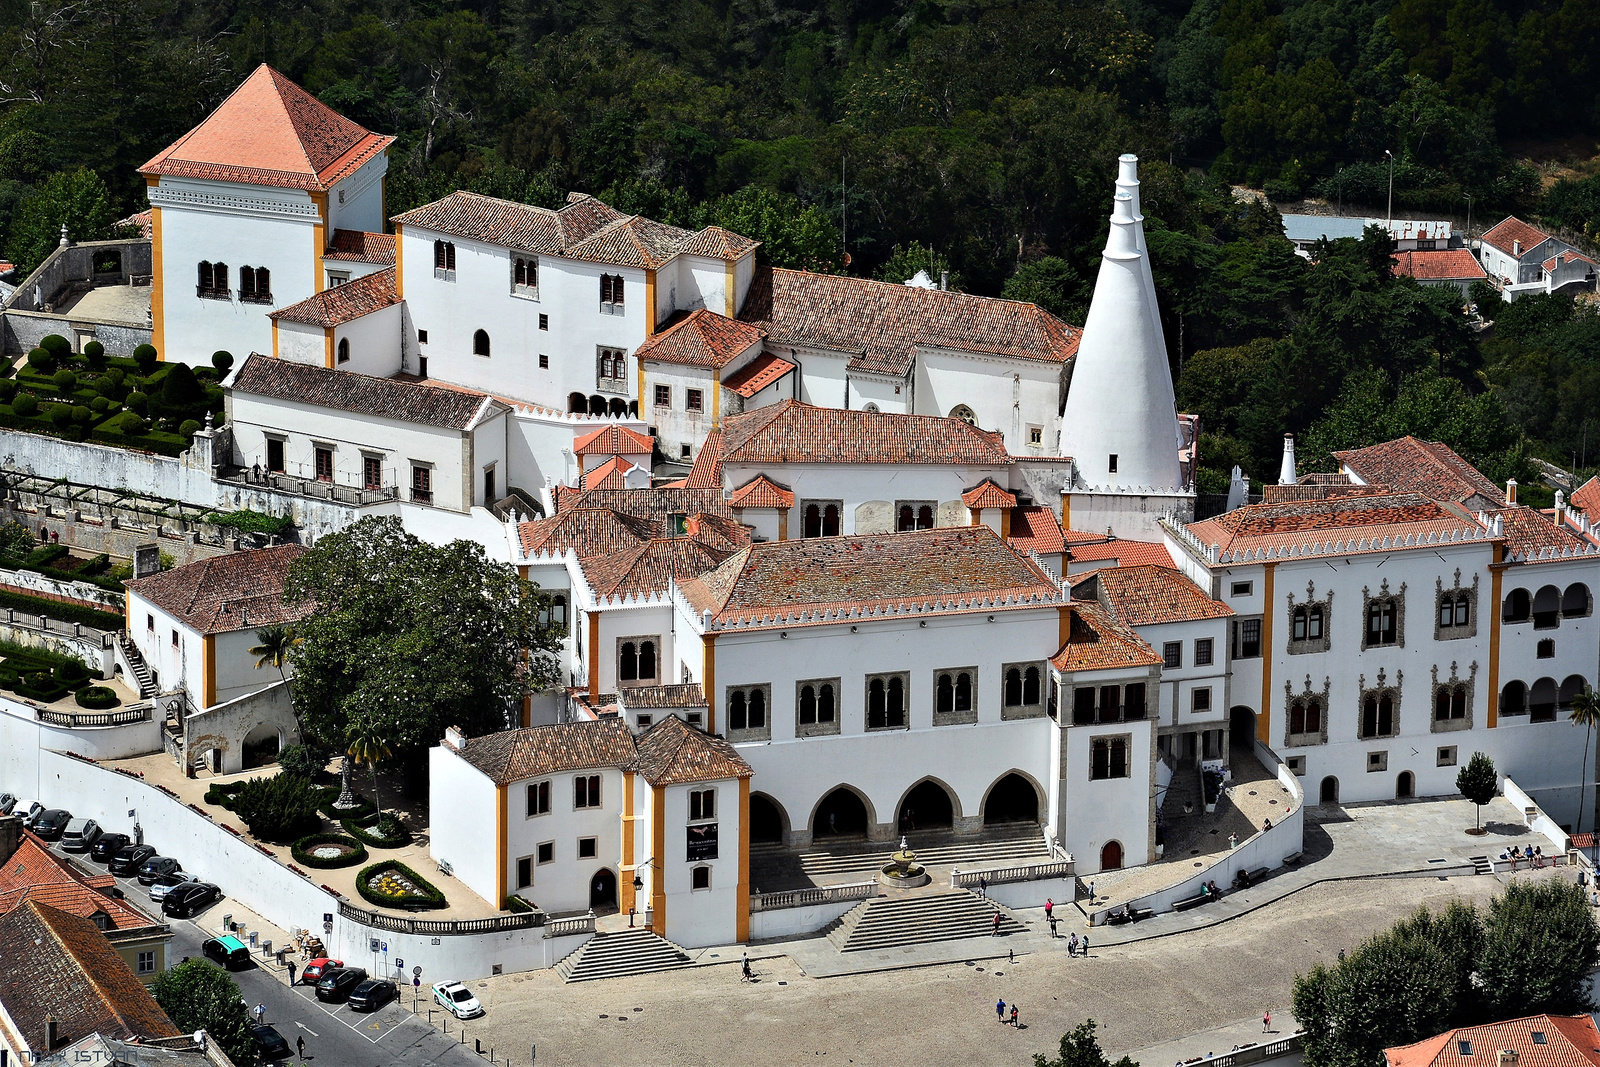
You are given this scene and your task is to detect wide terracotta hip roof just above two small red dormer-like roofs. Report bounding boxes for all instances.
[722,400,1011,466]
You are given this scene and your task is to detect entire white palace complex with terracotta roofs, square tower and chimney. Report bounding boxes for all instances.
[34,67,1600,945]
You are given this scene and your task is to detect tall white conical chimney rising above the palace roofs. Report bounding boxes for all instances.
[1061,155,1182,491]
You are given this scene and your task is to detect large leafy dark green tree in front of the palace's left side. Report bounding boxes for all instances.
[285,517,560,761]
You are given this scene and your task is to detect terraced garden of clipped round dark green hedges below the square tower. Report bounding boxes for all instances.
[0,334,234,456]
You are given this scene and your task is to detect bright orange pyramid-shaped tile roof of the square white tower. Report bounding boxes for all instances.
[139,64,394,192]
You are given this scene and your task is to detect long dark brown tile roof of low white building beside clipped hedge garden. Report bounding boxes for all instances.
[230,355,496,430]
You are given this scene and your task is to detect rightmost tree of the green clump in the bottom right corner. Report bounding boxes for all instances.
[1478,878,1600,1019]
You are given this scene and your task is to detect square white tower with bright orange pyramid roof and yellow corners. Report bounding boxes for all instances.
[139,64,394,363]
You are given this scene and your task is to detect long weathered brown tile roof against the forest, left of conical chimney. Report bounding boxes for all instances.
[739,267,1082,376]
